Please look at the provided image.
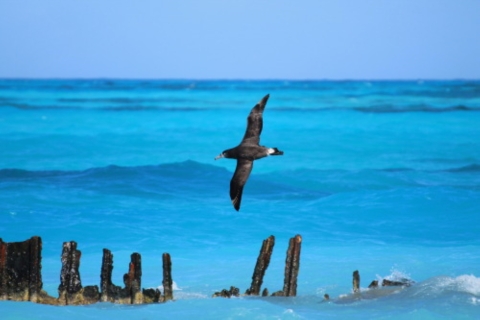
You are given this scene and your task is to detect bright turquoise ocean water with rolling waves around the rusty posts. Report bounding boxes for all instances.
[0,79,480,320]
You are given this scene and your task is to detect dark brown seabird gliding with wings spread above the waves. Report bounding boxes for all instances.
[214,94,283,211]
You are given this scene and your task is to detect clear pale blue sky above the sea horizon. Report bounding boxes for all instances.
[0,0,480,80]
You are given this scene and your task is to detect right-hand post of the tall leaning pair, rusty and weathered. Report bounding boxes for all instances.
[283,234,302,297]
